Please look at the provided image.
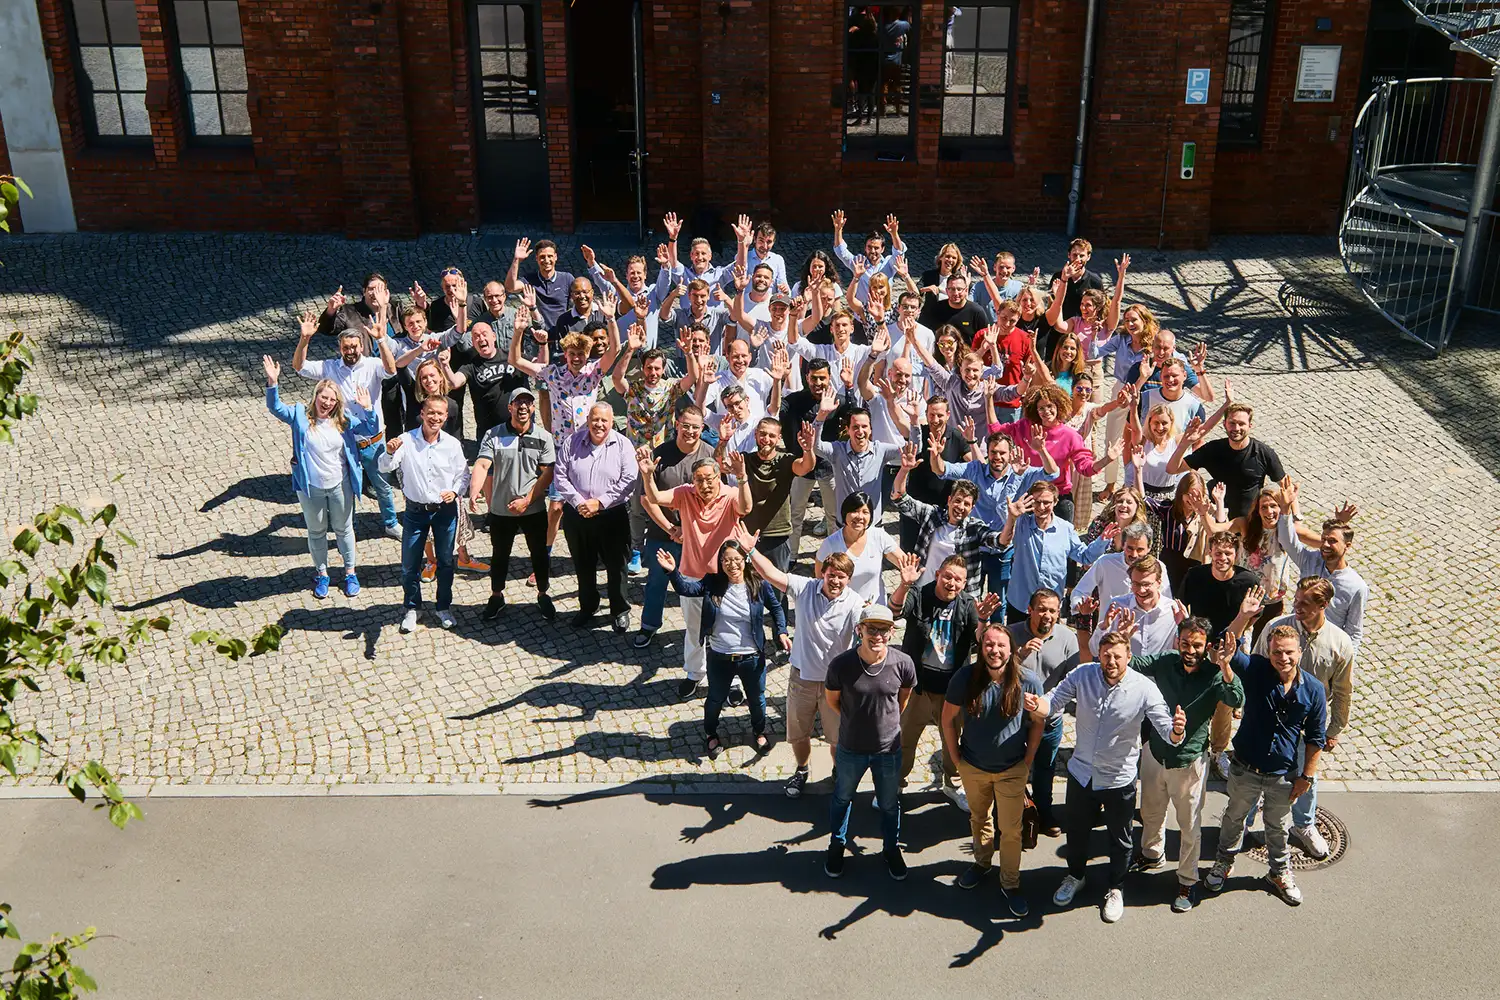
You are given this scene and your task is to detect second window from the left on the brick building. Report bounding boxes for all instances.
[173,0,251,144]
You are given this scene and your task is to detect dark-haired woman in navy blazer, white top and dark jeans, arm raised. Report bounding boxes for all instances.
[657,541,791,760]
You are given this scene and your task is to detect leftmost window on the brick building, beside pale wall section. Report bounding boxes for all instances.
[71,0,152,144]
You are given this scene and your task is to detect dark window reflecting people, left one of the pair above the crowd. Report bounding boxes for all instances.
[845,3,917,159]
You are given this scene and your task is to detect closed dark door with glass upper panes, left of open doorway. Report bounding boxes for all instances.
[470,0,549,222]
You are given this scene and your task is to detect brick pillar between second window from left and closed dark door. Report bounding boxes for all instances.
[332,0,417,238]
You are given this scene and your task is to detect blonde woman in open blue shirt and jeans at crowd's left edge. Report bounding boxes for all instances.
[261,354,380,598]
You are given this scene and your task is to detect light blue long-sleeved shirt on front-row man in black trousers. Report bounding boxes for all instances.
[1047,663,1182,789]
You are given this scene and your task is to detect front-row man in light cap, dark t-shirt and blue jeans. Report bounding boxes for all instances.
[824,604,917,880]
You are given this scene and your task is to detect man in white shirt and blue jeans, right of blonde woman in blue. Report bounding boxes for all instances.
[380,396,468,633]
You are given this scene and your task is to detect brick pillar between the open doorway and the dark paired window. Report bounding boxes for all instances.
[701,0,771,222]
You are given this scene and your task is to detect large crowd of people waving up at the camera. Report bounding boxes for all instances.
[264,211,1368,922]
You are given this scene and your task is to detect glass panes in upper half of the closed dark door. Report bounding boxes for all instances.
[479,3,542,139]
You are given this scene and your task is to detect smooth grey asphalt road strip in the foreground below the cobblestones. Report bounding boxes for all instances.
[0,793,1500,1000]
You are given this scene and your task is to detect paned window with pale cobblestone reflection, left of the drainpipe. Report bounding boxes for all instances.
[939,3,1016,159]
